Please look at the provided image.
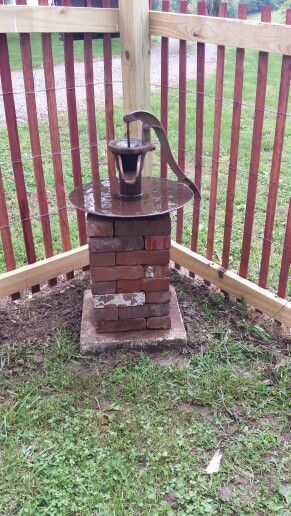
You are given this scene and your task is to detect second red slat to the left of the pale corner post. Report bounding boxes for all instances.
[84,0,99,181]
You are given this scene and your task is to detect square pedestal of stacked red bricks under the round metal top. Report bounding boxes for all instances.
[87,214,171,333]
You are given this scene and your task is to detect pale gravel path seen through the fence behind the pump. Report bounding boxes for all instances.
[0,40,216,125]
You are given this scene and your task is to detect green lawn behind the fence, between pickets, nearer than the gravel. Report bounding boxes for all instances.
[0,38,291,291]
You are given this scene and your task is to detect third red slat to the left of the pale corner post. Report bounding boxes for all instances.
[63,0,87,245]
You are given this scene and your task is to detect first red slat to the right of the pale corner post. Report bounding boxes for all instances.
[161,0,170,177]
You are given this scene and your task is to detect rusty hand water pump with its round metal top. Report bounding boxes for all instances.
[70,111,200,218]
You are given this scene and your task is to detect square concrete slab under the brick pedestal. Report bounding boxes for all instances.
[80,287,187,355]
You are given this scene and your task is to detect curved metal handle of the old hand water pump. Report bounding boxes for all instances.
[123,111,201,199]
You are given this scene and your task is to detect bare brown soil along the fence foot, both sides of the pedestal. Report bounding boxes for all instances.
[0,270,290,354]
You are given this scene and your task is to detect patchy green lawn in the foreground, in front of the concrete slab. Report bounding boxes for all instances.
[0,274,291,516]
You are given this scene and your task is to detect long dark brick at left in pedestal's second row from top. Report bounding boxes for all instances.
[89,236,144,253]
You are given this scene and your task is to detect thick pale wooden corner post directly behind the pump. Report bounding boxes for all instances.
[119,0,151,175]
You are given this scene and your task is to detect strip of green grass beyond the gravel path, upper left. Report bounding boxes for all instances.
[8,33,120,70]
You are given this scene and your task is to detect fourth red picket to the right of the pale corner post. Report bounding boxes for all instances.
[206,2,227,260]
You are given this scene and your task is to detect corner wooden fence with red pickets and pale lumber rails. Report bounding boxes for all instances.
[0,0,291,327]
